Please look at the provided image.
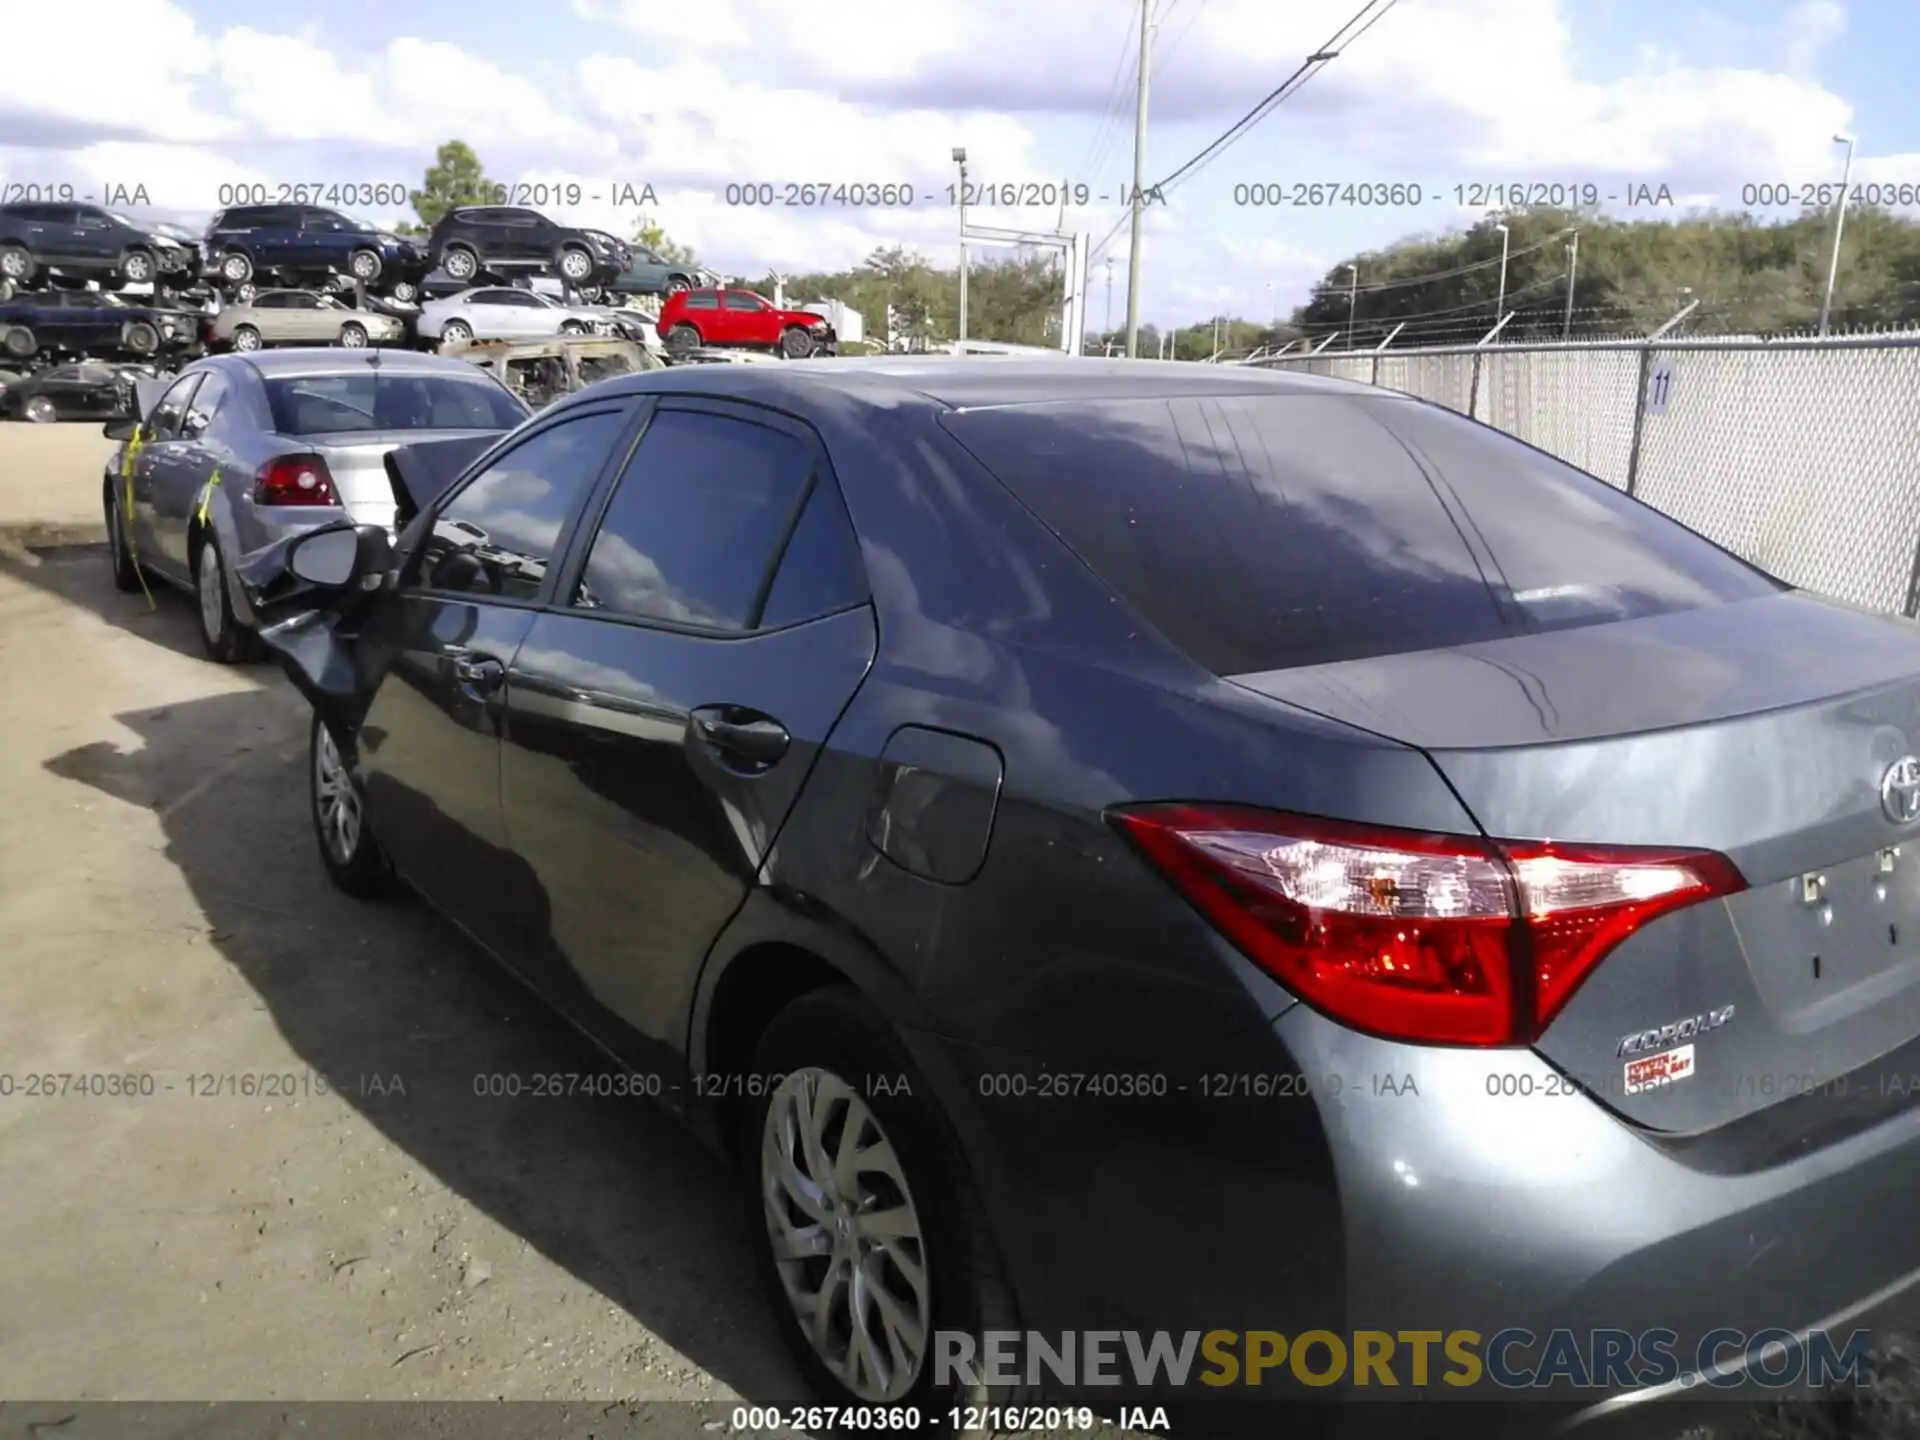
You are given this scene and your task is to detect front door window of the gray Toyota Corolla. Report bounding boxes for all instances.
[413,409,628,601]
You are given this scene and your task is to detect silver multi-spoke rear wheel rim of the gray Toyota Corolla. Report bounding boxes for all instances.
[760,1066,933,1402]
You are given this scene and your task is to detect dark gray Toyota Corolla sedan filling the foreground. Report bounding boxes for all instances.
[248,359,1920,1434]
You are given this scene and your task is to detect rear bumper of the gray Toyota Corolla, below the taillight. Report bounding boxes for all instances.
[916,1006,1920,1432]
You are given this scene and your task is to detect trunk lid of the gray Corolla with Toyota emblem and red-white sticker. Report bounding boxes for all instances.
[1235,593,1920,1133]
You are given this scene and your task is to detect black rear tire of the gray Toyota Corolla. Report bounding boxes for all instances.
[735,987,1021,1430]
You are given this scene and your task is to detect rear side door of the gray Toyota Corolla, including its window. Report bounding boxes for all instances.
[501,399,876,1058]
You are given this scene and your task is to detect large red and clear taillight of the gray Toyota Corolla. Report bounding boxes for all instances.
[1114,804,1745,1044]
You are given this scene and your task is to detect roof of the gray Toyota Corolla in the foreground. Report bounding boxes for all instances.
[595,355,1380,409]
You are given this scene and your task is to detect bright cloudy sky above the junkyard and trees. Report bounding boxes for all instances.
[0,0,1920,328]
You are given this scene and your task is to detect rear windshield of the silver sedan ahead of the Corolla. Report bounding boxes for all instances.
[267,369,528,436]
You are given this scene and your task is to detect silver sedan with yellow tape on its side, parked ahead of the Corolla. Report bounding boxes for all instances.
[102,349,530,664]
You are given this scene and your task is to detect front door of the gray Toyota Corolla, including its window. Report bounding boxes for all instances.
[357,403,632,962]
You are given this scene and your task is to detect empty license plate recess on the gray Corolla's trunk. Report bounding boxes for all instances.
[1734,845,1920,1014]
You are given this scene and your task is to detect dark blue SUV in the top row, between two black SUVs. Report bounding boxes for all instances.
[202,205,426,300]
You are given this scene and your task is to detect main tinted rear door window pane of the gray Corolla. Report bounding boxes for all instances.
[574,411,812,630]
